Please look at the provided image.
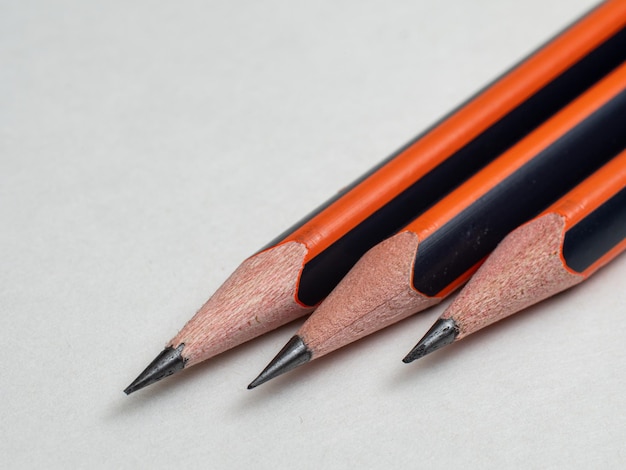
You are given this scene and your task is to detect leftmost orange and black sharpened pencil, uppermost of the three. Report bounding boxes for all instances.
[125,0,626,394]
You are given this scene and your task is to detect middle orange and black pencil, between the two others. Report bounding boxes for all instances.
[249,59,626,388]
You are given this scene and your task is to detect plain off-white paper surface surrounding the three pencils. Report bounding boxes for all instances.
[0,0,626,469]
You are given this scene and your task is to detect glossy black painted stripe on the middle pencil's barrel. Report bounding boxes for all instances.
[413,91,626,296]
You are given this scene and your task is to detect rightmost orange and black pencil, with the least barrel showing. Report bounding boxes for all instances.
[404,152,626,362]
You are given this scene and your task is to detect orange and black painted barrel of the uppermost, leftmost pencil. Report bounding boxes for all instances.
[278,0,626,306]
